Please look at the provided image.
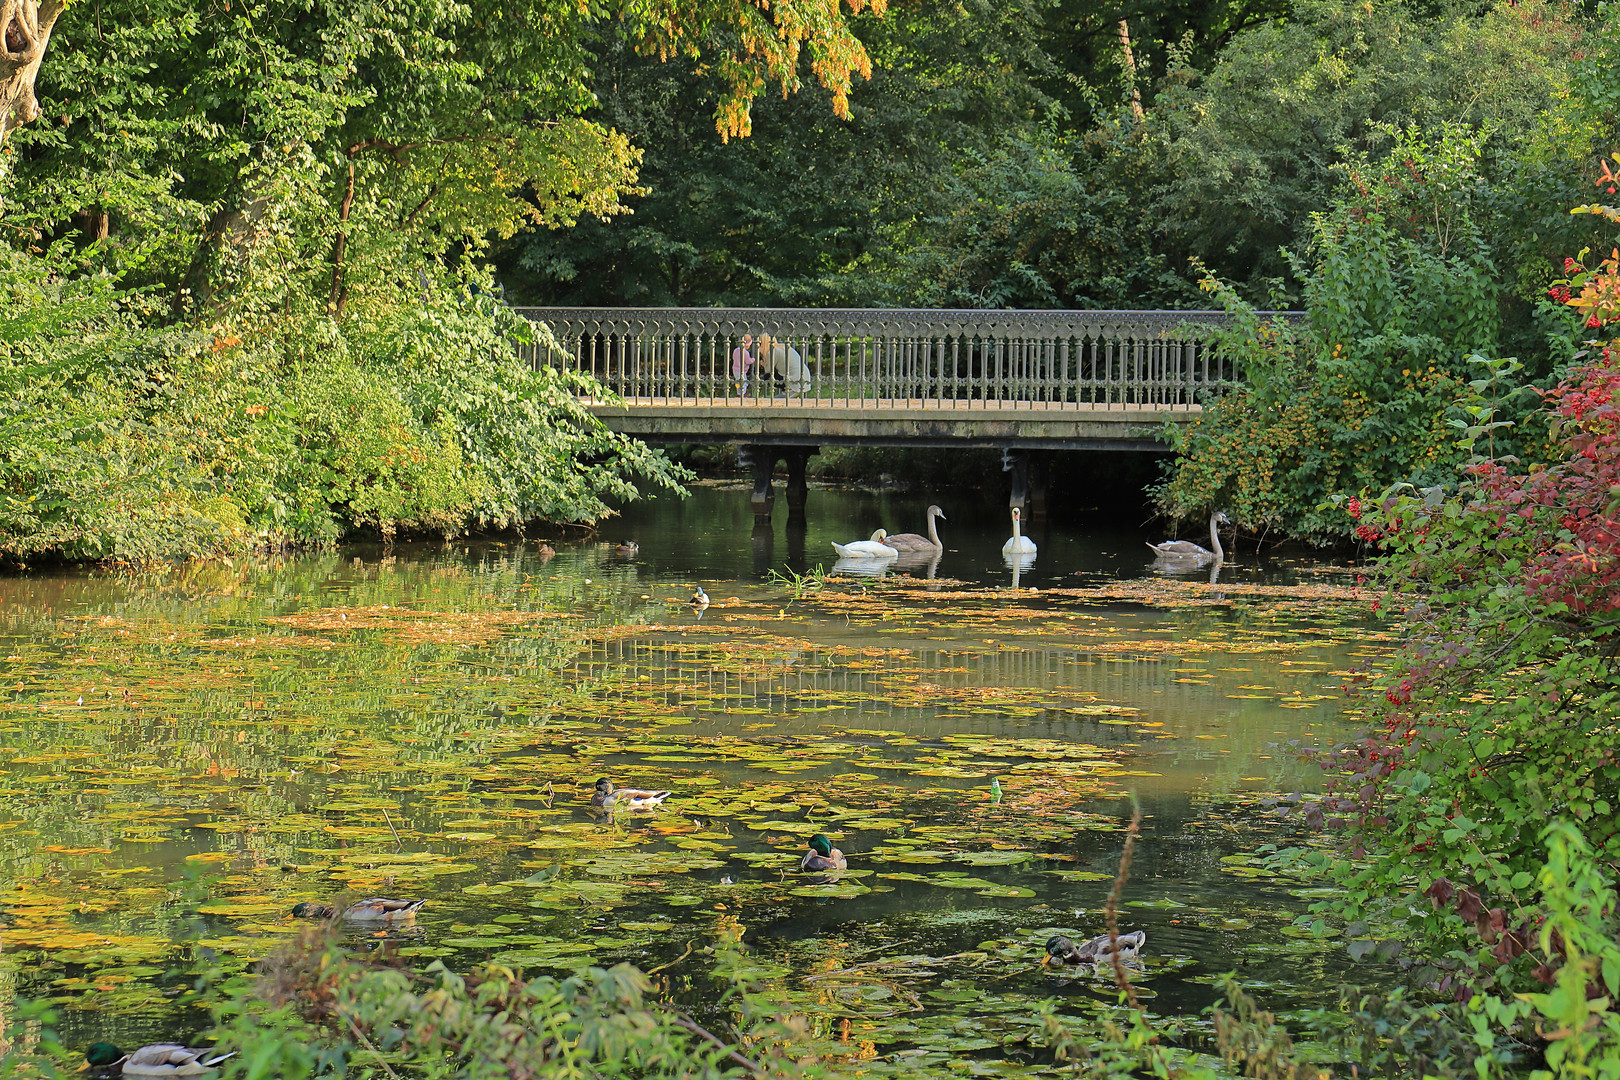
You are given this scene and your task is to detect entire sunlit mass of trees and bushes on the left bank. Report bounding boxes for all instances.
[0,0,939,560]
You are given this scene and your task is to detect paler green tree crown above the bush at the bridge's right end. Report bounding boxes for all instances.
[1153,0,1580,298]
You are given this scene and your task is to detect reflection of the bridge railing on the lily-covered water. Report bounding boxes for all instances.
[550,633,1349,780]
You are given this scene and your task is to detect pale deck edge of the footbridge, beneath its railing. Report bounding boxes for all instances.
[586,397,1202,450]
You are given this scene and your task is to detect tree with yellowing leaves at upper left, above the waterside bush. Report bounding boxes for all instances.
[10,0,883,317]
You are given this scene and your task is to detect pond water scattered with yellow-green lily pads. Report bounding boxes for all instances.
[0,486,1387,1072]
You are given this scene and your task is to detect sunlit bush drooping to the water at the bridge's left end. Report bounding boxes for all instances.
[0,253,682,560]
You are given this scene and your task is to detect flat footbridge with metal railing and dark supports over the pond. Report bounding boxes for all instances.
[517,308,1283,513]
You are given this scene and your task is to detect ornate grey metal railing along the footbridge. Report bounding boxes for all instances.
[517,308,1283,408]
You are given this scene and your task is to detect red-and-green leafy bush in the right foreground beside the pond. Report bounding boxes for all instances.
[1283,194,1620,1077]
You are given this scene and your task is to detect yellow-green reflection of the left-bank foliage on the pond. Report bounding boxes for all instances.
[0,557,620,976]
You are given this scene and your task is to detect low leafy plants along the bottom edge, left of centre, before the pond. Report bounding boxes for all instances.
[0,934,800,1080]
